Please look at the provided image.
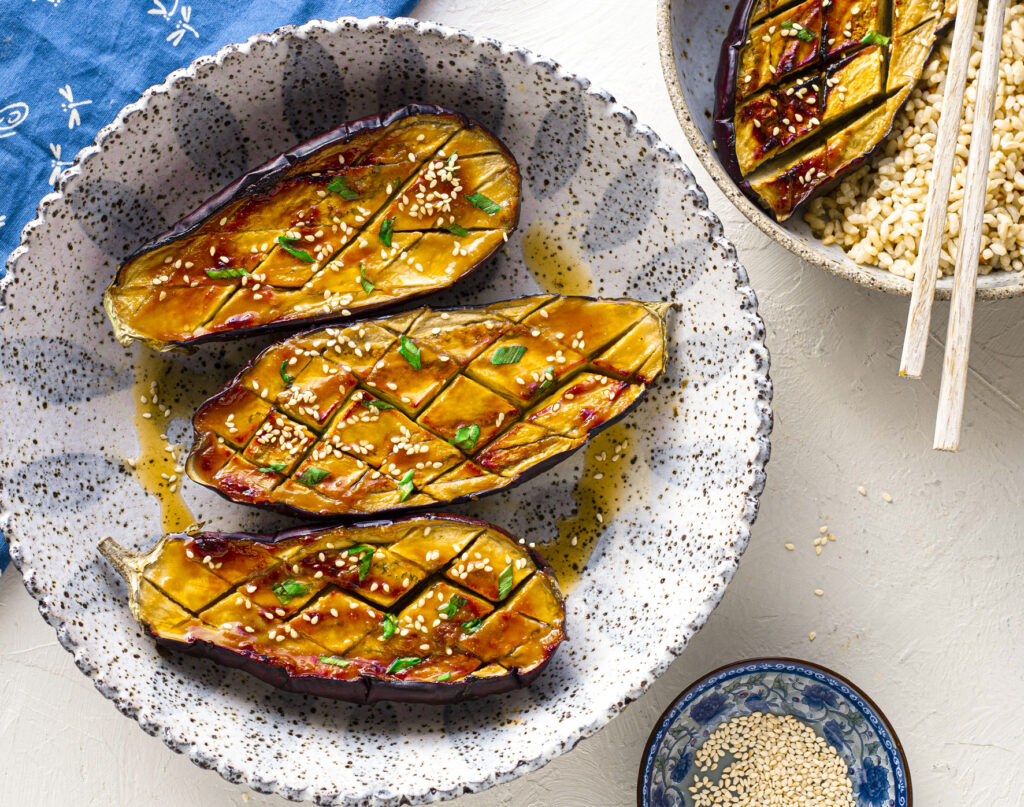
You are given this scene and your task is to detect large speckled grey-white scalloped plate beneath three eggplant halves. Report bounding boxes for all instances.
[0,18,771,805]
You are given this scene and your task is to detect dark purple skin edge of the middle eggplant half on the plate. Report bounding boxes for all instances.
[189,296,668,523]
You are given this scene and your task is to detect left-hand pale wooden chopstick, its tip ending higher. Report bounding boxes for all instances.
[899,0,978,378]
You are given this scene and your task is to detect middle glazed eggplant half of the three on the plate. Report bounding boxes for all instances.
[186,295,668,518]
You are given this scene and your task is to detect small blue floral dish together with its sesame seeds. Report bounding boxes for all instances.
[637,659,912,807]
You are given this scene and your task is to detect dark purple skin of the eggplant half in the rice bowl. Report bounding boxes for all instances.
[712,0,951,223]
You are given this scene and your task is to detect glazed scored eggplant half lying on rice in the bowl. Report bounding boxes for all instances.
[714,0,950,221]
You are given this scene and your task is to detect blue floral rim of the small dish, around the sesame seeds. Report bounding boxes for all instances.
[637,659,913,807]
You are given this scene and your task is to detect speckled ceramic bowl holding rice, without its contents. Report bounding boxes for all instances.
[657,0,1024,300]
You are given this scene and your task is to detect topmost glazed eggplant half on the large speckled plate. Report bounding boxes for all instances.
[103,105,520,350]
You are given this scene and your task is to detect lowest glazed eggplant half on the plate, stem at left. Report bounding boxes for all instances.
[99,515,565,704]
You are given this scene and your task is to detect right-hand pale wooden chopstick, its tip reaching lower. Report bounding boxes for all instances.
[933,0,1008,451]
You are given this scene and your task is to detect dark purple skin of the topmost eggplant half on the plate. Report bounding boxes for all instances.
[112,103,521,352]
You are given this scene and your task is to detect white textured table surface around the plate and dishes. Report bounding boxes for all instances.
[6,0,1024,807]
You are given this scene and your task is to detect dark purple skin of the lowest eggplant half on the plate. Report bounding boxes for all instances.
[137,513,569,706]
